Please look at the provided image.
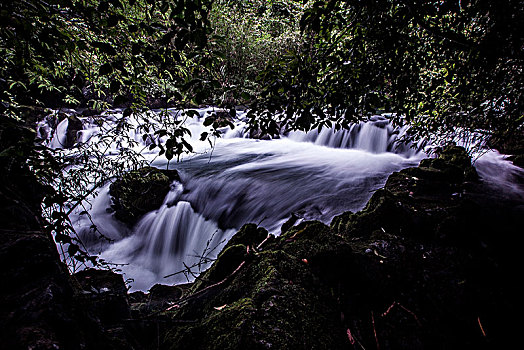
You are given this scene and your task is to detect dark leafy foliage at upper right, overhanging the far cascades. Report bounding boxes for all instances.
[251,0,524,146]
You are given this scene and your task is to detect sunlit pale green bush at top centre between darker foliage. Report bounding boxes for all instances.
[204,0,305,106]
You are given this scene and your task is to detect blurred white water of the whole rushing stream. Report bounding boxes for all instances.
[42,109,524,290]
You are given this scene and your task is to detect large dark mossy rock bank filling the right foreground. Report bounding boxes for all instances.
[123,147,520,349]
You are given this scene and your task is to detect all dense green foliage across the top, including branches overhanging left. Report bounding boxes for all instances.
[0,0,524,261]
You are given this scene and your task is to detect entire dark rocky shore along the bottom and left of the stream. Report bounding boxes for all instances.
[0,133,524,349]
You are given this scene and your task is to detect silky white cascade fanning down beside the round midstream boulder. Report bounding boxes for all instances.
[101,183,236,290]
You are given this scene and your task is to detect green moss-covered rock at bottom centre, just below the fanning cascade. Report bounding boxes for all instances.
[165,222,347,349]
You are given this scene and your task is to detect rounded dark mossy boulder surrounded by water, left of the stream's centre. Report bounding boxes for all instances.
[109,167,180,225]
